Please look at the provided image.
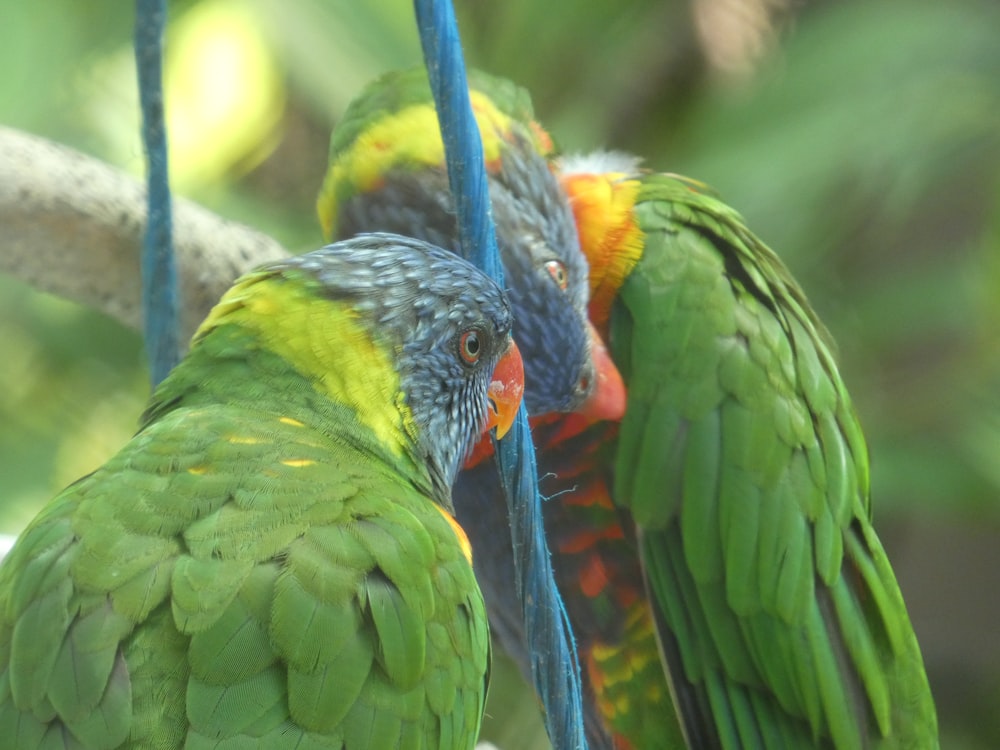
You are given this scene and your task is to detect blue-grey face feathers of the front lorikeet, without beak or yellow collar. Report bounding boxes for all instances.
[271,233,513,497]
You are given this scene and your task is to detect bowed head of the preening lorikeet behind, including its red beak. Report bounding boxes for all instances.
[317,68,625,419]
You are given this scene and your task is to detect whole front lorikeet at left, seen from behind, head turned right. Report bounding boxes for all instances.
[0,234,523,750]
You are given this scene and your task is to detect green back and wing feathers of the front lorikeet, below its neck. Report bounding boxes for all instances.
[0,407,488,748]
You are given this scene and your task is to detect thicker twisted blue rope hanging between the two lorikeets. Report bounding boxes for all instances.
[414,0,586,750]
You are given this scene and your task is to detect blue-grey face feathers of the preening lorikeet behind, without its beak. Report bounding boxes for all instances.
[338,130,596,414]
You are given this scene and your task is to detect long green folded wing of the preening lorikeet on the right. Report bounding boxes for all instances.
[610,175,937,749]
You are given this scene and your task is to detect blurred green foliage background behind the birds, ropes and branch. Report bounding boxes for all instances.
[0,0,1000,750]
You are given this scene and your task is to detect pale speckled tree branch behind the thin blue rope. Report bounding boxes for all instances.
[0,127,289,341]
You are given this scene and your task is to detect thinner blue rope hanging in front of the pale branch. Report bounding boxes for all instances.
[135,0,180,386]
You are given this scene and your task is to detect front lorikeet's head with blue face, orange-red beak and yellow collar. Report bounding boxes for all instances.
[192,234,524,503]
